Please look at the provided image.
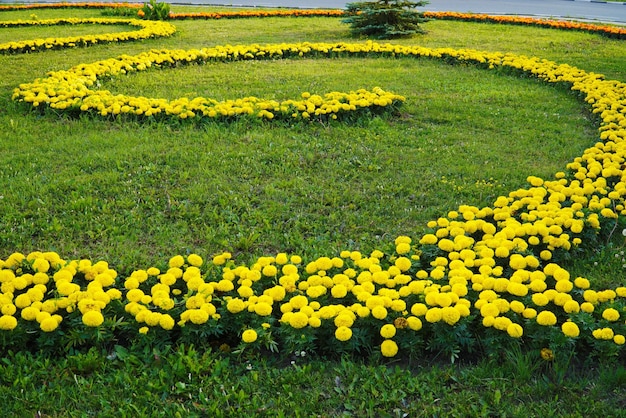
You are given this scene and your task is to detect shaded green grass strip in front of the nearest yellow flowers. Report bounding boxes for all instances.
[0,346,626,418]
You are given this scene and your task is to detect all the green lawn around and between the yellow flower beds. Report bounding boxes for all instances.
[0,4,626,417]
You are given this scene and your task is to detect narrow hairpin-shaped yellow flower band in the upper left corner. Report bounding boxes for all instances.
[0,18,176,53]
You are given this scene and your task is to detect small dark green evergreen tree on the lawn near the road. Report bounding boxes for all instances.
[342,0,428,39]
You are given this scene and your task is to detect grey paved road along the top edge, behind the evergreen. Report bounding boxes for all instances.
[0,0,626,25]
